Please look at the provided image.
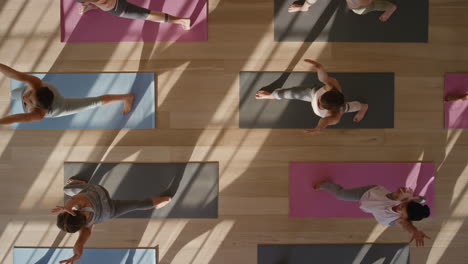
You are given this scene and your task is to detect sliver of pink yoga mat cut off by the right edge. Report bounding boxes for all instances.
[444,73,468,128]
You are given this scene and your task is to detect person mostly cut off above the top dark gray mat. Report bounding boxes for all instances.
[288,0,397,22]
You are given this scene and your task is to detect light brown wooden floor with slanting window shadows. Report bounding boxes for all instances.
[0,0,468,264]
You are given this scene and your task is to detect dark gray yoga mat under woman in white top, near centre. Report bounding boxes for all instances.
[239,72,394,128]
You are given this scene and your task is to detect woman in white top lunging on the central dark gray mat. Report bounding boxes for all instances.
[255,60,369,134]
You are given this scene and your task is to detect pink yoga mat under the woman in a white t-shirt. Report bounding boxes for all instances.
[289,163,434,218]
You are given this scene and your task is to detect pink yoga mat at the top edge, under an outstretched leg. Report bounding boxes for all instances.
[60,0,207,42]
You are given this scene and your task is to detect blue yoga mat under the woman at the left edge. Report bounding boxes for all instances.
[10,73,156,129]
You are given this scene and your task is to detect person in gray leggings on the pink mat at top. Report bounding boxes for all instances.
[75,0,190,30]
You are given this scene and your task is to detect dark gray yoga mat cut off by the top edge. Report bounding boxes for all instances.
[274,0,429,42]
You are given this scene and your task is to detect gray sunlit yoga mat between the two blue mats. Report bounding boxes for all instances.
[64,162,218,218]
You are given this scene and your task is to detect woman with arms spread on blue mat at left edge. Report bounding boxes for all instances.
[0,63,134,125]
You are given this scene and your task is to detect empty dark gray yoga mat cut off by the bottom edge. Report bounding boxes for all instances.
[257,244,409,264]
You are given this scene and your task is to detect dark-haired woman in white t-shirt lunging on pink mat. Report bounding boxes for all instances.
[313,181,431,246]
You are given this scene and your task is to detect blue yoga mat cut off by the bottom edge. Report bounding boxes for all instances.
[13,248,157,264]
